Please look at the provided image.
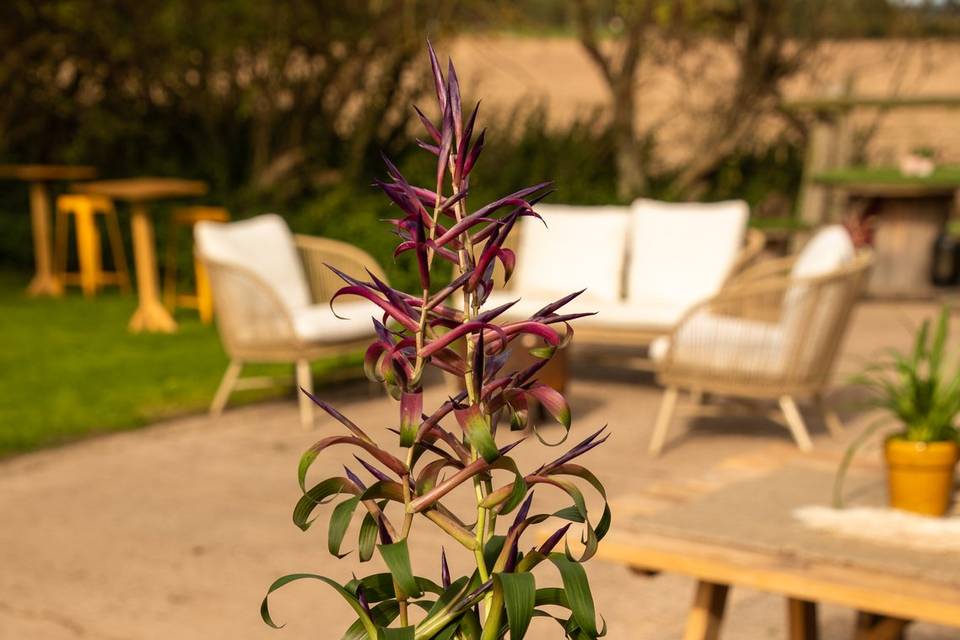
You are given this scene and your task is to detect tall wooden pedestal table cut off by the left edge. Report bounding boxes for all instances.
[0,164,97,296]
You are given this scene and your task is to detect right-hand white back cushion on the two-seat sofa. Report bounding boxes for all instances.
[627,199,750,305]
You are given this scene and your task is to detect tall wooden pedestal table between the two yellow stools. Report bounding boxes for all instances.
[75,178,207,333]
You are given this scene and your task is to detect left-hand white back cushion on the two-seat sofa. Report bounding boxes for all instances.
[513,204,630,301]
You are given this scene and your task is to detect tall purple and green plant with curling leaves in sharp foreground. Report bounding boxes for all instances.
[261,44,610,640]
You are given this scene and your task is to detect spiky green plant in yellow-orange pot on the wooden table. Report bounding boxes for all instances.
[834,307,960,516]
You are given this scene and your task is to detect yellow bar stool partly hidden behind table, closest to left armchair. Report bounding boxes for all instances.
[163,206,230,324]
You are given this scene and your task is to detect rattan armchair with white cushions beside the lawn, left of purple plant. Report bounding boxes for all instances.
[196,215,386,428]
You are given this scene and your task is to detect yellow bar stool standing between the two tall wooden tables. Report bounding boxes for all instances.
[54,194,130,297]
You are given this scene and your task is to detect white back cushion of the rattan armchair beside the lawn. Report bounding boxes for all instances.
[194,213,310,312]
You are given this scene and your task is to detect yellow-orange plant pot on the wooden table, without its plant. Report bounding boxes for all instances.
[884,437,958,516]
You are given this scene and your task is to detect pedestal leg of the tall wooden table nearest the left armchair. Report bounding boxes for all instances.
[129,202,177,333]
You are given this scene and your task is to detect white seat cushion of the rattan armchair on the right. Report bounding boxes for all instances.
[650,312,785,374]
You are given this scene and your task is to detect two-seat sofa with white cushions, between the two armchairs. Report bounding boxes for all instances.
[484,199,764,346]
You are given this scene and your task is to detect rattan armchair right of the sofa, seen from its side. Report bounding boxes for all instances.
[650,227,872,455]
